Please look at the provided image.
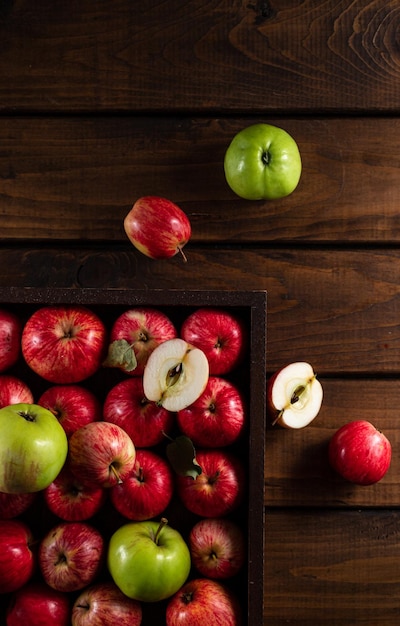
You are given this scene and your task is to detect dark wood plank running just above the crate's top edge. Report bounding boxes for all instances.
[0,243,400,376]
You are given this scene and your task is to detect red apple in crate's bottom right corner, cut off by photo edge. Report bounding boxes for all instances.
[166,578,242,626]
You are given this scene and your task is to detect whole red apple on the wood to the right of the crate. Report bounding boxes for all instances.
[328,420,392,485]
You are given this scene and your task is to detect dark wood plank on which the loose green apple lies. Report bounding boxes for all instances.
[0,117,400,244]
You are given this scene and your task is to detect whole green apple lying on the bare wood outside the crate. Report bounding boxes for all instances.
[224,124,301,200]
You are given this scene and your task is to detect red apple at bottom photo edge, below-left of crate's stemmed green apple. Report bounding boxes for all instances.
[71,582,142,626]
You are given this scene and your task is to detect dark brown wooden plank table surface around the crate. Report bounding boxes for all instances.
[0,0,400,626]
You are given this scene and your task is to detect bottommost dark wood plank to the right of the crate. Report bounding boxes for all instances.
[264,510,400,626]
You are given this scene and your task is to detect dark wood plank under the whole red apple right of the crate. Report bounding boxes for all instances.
[265,375,400,508]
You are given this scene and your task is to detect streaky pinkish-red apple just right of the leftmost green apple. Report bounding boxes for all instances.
[68,422,136,487]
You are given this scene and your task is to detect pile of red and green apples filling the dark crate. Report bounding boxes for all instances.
[0,304,248,626]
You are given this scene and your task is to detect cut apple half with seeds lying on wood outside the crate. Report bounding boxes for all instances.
[267,361,323,428]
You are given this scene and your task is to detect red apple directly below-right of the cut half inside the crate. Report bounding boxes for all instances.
[177,376,246,448]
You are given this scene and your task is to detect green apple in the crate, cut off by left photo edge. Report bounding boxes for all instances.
[0,403,68,493]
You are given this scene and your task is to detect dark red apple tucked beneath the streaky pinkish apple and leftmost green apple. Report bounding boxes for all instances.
[43,463,106,522]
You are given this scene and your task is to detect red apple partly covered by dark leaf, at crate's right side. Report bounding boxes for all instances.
[176,448,246,517]
